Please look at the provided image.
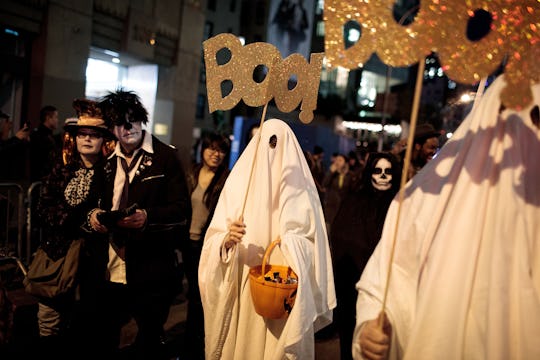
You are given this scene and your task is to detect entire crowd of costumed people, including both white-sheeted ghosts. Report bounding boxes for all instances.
[0,74,540,360]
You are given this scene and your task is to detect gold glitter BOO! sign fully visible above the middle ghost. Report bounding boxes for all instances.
[203,34,324,124]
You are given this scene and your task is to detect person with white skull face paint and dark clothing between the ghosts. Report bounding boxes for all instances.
[330,153,401,359]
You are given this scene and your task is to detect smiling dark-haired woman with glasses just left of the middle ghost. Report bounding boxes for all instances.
[183,133,230,359]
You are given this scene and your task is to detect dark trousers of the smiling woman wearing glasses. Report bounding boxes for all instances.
[183,240,204,359]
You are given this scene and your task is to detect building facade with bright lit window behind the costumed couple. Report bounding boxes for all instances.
[0,0,206,166]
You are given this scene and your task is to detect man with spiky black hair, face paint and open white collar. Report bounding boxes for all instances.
[93,90,191,359]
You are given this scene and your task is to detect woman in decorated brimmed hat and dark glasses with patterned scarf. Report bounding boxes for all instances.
[30,99,114,357]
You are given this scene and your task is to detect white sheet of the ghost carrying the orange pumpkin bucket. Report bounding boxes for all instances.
[199,119,336,360]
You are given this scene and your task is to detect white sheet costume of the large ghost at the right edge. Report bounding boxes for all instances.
[353,76,540,360]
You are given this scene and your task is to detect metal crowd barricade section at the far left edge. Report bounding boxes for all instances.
[0,183,25,257]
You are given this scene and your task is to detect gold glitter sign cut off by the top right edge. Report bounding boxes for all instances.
[324,0,540,108]
